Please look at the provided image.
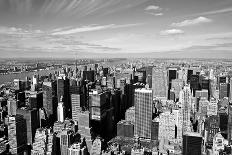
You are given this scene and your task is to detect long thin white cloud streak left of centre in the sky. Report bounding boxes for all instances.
[52,23,142,35]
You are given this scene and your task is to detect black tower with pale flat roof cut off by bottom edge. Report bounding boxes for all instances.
[183,132,202,155]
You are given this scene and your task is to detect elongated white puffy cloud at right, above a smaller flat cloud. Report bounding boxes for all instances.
[171,17,212,27]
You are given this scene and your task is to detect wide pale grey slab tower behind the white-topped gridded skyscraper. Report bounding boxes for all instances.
[152,68,168,98]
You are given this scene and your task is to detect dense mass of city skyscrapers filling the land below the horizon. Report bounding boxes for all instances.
[0,59,232,155]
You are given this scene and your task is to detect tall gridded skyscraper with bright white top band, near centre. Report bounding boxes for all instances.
[135,88,153,139]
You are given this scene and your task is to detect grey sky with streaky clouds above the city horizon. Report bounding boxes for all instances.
[0,0,232,58]
